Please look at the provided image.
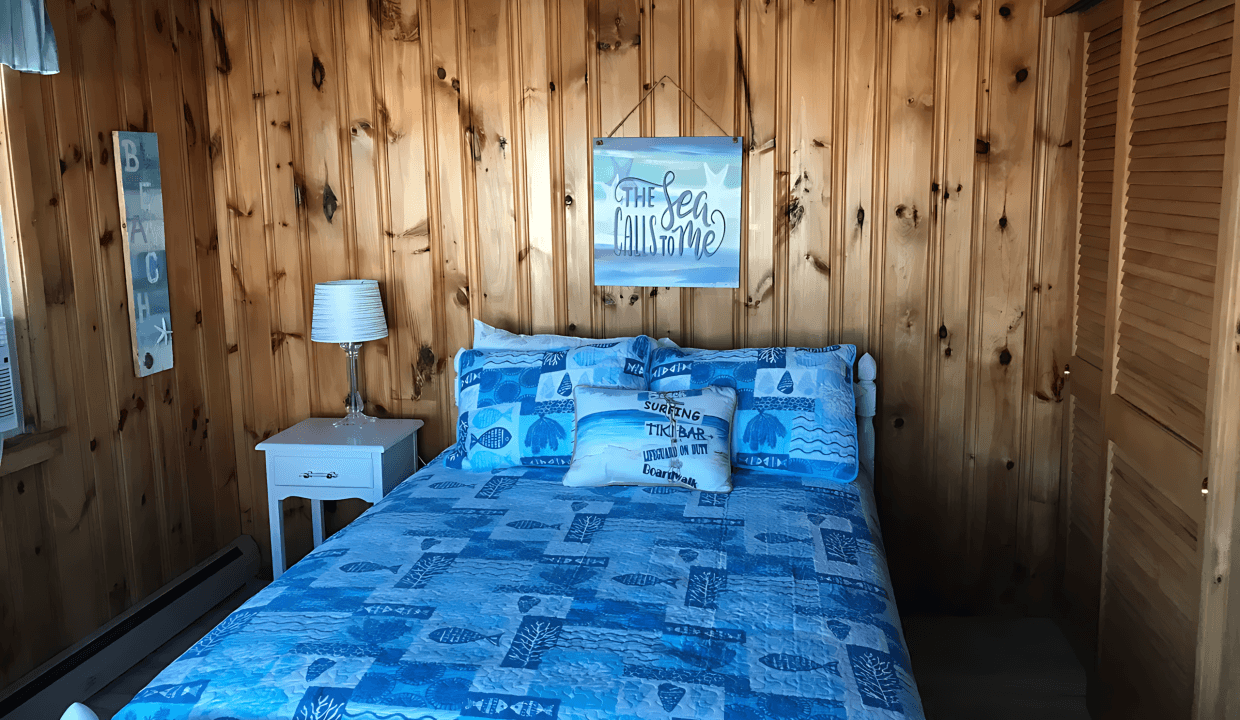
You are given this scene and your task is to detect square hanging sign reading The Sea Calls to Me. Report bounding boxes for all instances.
[594,138,742,288]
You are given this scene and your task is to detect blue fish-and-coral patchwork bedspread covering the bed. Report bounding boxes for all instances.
[117,459,924,720]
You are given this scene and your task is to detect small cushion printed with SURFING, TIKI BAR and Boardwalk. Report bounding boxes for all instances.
[564,385,737,492]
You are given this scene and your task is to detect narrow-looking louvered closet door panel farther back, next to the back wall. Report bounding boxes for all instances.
[1064,0,1122,639]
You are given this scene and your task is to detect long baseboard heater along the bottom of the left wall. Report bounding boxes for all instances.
[0,535,259,720]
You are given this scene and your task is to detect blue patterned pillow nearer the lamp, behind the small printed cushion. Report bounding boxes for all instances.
[446,335,653,470]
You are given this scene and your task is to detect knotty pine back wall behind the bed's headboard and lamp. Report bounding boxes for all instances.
[201,0,1081,607]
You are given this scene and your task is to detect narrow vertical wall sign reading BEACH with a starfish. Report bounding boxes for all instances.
[112,131,172,378]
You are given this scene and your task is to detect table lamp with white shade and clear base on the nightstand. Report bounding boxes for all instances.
[310,280,387,428]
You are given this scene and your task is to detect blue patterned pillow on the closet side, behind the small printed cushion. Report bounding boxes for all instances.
[650,345,858,482]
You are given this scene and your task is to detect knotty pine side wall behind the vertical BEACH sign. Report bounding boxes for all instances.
[0,0,241,688]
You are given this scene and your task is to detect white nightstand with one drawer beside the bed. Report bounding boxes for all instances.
[257,418,422,577]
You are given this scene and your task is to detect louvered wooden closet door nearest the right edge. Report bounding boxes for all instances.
[1086,0,1235,718]
